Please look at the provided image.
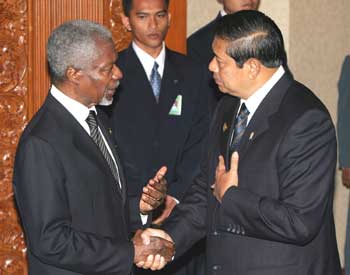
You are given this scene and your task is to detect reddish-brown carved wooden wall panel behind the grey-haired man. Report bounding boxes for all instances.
[0,0,186,275]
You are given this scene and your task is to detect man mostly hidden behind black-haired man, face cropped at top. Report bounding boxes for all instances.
[187,0,260,112]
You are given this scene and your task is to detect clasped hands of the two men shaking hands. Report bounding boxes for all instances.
[133,229,175,270]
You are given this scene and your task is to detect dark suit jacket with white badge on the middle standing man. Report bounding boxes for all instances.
[112,46,209,232]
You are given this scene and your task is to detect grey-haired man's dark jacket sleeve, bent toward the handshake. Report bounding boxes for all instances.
[14,137,134,274]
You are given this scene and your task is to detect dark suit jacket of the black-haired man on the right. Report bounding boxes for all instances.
[164,74,340,275]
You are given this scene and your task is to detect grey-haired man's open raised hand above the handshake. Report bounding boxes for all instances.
[140,166,167,215]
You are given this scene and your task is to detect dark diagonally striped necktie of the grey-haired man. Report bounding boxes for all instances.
[86,111,121,187]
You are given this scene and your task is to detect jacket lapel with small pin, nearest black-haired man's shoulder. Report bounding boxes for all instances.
[238,73,293,161]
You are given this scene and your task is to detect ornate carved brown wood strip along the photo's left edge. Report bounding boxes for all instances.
[0,0,28,275]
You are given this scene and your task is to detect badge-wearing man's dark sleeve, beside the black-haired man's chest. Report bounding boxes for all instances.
[168,66,210,202]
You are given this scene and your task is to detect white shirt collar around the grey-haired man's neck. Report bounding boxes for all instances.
[50,84,96,124]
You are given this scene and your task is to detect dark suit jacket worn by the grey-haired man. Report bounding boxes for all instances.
[14,95,134,275]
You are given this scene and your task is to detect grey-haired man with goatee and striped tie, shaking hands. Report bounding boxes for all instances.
[13,20,171,275]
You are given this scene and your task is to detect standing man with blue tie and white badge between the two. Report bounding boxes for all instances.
[112,0,209,274]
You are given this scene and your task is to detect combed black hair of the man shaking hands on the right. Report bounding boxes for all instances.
[215,10,285,68]
